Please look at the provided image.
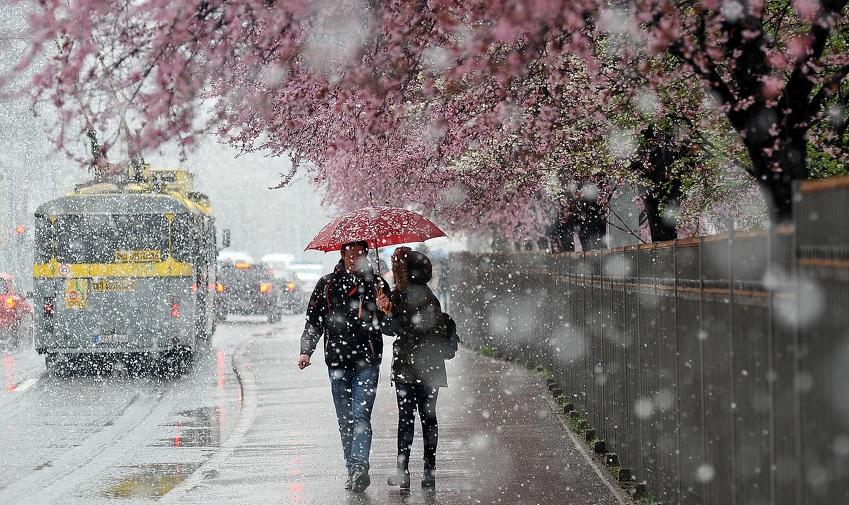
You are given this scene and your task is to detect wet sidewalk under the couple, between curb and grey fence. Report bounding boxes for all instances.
[162,318,618,505]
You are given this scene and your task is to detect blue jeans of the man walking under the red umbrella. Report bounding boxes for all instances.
[328,366,380,475]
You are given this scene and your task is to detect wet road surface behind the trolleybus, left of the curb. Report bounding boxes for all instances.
[0,316,264,504]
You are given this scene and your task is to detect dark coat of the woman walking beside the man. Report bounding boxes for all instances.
[384,275,448,387]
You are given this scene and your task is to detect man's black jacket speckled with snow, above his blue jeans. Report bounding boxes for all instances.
[301,261,389,370]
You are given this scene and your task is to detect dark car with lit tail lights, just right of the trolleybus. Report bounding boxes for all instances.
[215,260,281,323]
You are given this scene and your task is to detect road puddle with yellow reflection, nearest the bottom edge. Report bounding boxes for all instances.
[105,463,200,498]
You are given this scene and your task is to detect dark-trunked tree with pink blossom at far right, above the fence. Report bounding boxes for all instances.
[628,0,849,222]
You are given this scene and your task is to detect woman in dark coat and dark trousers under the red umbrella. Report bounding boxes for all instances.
[377,247,448,490]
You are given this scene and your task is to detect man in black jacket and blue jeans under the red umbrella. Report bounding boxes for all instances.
[298,242,389,493]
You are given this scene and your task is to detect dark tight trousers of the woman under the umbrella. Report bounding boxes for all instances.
[395,382,439,470]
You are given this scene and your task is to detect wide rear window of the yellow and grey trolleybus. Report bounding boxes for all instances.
[56,214,168,263]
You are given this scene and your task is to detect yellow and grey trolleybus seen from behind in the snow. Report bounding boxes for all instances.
[33,167,229,371]
